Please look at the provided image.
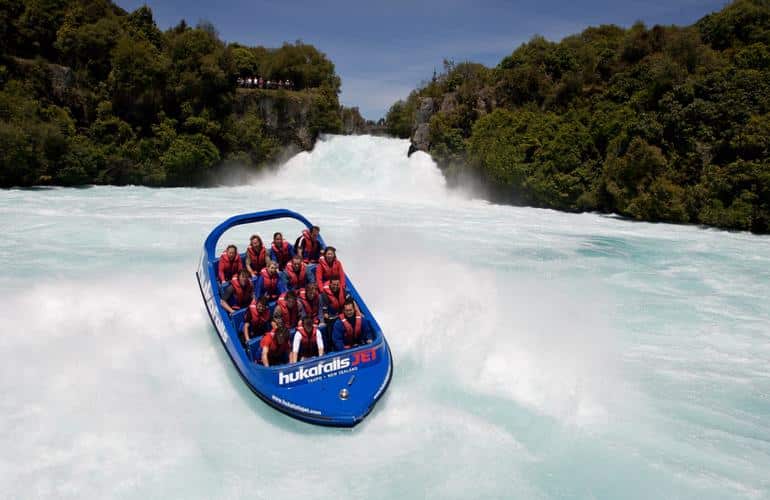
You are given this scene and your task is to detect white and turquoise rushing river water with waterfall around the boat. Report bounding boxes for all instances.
[0,137,770,499]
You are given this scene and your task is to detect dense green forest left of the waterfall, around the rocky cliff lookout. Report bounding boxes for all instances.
[0,0,341,187]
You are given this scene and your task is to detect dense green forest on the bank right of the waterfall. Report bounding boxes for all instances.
[386,0,770,233]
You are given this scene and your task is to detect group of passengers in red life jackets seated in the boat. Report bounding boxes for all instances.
[218,226,374,366]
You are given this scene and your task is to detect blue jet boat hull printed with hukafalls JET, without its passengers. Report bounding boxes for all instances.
[196,209,393,427]
